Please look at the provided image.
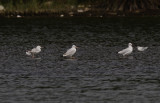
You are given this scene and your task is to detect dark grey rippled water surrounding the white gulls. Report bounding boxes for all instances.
[0,17,160,103]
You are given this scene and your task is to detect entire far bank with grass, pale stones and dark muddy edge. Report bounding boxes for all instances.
[0,0,160,16]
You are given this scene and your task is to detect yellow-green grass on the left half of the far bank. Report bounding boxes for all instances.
[0,0,77,12]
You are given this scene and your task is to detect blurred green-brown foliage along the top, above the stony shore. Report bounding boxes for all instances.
[0,0,160,12]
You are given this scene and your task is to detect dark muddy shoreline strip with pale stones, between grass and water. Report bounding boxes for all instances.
[0,9,160,18]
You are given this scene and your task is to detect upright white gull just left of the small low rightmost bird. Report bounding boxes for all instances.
[118,43,133,56]
